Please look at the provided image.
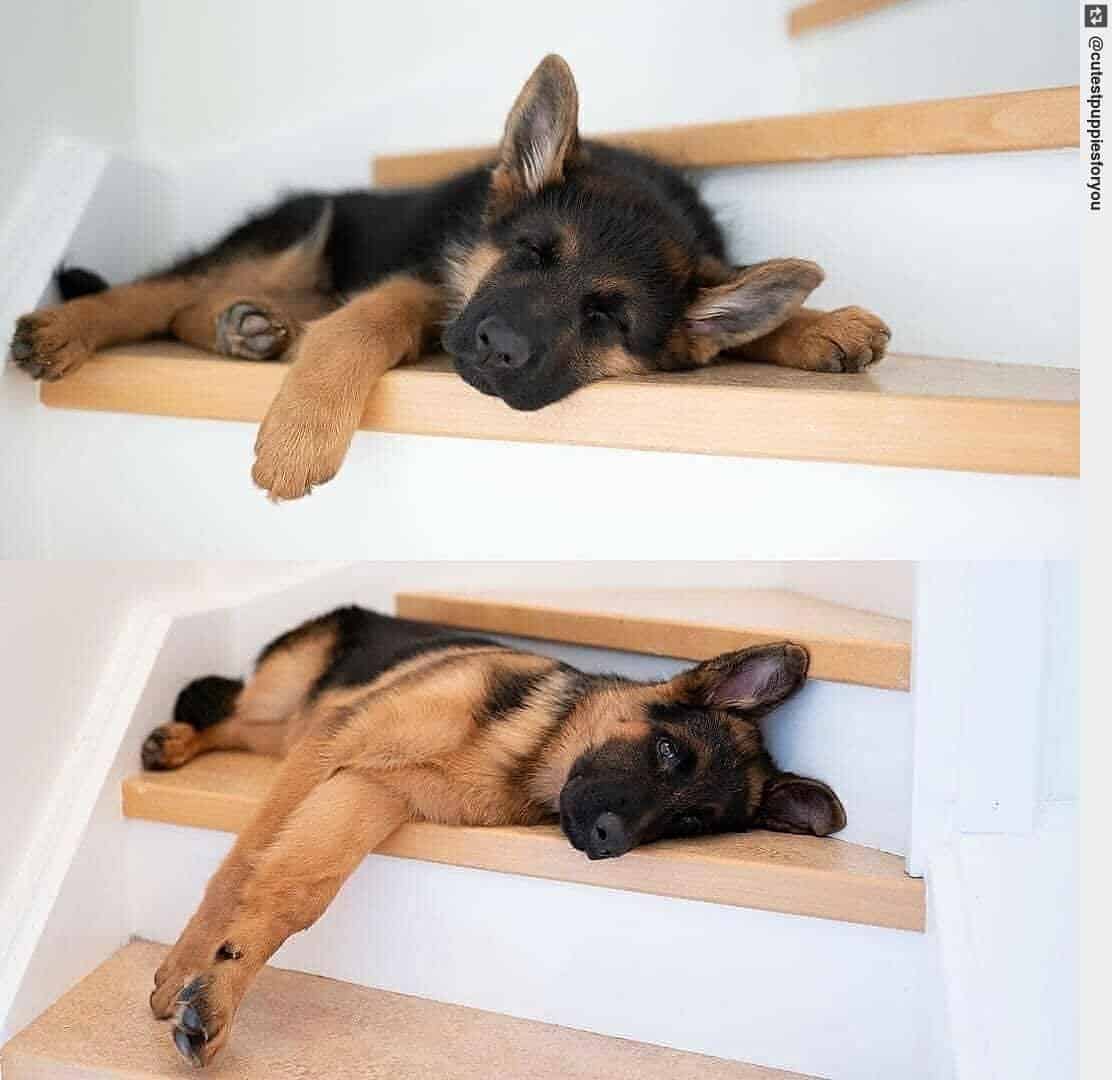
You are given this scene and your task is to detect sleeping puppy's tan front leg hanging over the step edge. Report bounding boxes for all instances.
[251,275,443,499]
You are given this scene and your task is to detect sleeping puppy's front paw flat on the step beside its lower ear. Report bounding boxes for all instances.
[733,307,892,371]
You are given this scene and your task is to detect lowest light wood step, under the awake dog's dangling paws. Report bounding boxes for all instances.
[0,941,818,1080]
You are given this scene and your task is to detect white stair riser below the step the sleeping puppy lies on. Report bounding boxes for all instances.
[23,409,1080,559]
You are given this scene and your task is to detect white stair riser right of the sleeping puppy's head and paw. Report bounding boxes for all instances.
[703,150,1080,367]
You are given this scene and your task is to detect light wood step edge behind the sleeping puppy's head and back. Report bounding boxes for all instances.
[371,86,1080,188]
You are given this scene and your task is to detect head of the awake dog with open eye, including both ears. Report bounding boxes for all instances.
[559,643,845,859]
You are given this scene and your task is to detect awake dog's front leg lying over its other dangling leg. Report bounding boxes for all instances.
[166,770,409,1066]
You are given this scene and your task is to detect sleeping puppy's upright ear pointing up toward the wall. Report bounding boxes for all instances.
[492,53,579,208]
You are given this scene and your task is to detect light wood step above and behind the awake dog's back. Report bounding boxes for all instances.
[397,588,911,690]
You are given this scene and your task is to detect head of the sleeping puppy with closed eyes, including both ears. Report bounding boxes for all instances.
[443,56,822,409]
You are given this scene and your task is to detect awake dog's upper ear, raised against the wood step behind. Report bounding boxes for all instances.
[668,642,811,716]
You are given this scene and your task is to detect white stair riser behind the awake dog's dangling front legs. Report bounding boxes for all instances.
[128,822,929,1080]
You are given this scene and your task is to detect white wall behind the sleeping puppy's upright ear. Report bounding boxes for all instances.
[138,0,797,249]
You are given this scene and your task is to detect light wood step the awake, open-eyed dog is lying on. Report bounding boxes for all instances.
[123,752,925,931]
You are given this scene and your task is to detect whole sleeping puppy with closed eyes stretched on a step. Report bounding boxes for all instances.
[12,56,888,498]
